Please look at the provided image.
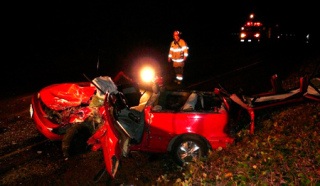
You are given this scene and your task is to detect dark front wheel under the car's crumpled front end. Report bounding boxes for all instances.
[62,123,91,157]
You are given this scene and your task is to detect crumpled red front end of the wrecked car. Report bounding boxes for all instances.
[30,73,141,156]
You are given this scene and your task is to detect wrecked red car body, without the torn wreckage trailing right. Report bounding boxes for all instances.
[30,72,240,161]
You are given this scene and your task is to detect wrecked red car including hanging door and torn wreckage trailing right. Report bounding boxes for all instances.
[30,68,320,180]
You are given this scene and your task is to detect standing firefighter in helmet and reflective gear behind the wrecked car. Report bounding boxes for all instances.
[168,30,189,84]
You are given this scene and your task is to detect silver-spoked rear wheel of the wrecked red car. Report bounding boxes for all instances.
[171,136,209,166]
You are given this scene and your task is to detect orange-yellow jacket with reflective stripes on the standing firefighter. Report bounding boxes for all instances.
[168,39,189,62]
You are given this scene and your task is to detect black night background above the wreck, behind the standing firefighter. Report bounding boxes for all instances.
[1,0,319,97]
